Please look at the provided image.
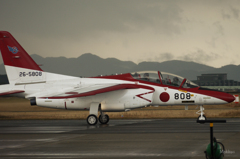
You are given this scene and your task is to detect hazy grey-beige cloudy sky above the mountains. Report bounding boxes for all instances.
[0,0,240,67]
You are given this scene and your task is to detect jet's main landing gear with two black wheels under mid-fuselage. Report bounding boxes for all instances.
[87,103,109,125]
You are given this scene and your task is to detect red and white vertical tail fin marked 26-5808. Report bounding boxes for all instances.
[0,31,44,84]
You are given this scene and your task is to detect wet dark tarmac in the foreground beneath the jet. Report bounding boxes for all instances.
[0,118,240,159]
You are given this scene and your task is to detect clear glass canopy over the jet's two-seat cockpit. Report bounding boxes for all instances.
[131,71,198,88]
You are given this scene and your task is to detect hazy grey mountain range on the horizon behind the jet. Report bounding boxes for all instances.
[0,53,240,81]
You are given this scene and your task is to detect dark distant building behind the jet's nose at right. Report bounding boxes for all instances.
[193,73,240,92]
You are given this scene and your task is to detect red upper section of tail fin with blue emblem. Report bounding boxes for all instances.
[0,31,42,71]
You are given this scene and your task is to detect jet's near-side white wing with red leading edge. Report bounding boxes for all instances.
[41,84,155,99]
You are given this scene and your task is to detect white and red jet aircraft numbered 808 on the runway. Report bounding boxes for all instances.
[0,31,235,125]
